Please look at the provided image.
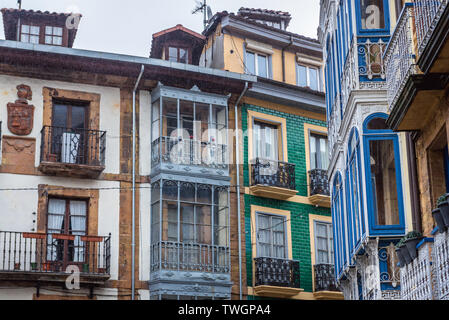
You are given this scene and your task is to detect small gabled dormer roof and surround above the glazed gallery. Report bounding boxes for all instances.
[150,24,206,65]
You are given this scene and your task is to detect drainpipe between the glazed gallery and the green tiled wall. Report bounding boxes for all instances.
[234,82,248,300]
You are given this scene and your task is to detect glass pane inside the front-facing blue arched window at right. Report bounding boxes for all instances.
[370,140,399,225]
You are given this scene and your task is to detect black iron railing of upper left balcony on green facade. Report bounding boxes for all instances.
[251,158,296,190]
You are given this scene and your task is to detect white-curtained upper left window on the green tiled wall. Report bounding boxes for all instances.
[253,121,279,161]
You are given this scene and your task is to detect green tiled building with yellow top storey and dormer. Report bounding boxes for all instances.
[200,8,342,300]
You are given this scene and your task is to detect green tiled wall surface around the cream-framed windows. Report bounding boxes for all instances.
[241,104,331,298]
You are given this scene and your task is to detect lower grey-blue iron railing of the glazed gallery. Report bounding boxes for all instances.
[151,241,231,273]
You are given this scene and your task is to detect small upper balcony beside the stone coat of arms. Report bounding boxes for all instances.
[39,126,106,178]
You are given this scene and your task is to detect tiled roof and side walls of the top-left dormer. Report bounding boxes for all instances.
[0,8,82,47]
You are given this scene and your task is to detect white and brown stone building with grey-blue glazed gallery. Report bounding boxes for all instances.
[0,9,256,299]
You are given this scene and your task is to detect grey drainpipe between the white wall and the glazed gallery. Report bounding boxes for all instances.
[131,65,145,300]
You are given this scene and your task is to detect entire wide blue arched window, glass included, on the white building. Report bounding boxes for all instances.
[363,113,404,235]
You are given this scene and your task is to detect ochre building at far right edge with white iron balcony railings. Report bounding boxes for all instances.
[385,0,449,300]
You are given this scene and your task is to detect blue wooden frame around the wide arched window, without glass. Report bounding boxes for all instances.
[363,113,405,236]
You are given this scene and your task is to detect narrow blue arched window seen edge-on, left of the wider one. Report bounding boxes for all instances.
[346,128,365,253]
